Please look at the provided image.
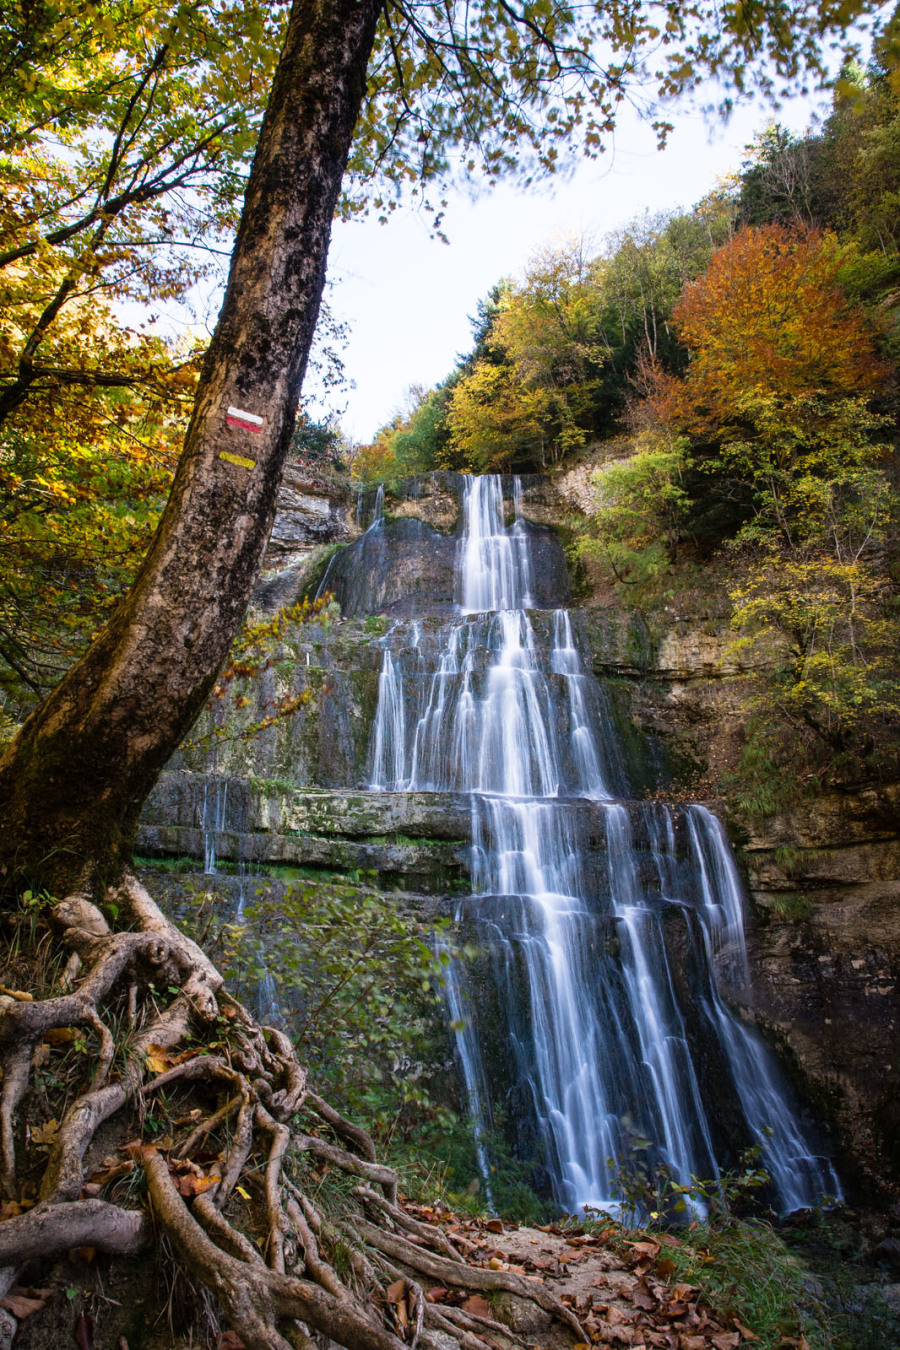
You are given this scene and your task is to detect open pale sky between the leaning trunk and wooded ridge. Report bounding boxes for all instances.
[318,81,830,441]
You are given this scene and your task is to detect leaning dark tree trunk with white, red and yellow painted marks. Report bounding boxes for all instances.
[0,0,382,894]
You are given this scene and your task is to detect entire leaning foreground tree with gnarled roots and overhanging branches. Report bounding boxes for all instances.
[0,0,890,1350]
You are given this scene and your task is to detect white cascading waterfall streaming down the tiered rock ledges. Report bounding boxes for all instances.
[370,475,839,1211]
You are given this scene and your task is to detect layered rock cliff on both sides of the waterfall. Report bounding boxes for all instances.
[139,471,900,1193]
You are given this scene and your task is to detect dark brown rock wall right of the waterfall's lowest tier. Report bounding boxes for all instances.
[745,783,900,1193]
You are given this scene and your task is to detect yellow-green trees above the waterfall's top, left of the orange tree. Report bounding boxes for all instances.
[443,202,735,470]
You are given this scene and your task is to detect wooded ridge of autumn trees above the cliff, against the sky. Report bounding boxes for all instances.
[356,20,900,479]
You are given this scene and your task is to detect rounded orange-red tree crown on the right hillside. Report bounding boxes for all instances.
[661,225,887,431]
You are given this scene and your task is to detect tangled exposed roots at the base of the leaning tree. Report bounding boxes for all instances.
[0,876,586,1350]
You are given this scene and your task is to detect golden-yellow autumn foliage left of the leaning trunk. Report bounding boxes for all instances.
[0,0,285,707]
